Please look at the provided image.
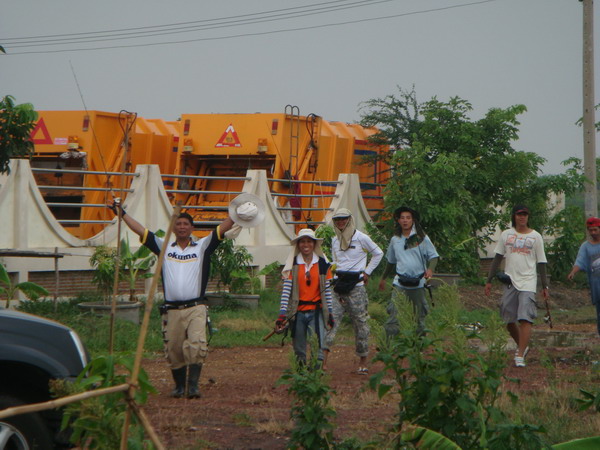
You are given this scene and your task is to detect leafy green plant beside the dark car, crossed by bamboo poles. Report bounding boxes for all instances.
[52,354,156,449]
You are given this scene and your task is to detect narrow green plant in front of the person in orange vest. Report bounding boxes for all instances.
[278,339,336,449]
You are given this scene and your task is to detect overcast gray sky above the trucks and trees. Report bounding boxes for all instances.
[0,0,600,173]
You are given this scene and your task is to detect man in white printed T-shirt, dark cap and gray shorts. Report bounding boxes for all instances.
[485,205,548,367]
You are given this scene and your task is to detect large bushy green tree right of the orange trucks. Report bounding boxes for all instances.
[361,88,583,276]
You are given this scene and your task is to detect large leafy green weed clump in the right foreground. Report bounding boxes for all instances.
[369,286,544,449]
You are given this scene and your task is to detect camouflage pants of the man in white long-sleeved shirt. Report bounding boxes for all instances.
[325,286,369,357]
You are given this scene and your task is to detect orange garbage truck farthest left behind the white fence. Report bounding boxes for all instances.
[31,111,178,238]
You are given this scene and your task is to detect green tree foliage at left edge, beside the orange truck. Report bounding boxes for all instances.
[0,95,38,173]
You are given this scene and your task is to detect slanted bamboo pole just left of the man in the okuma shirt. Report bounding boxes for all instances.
[120,204,181,450]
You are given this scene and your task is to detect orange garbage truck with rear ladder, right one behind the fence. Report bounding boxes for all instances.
[175,108,387,224]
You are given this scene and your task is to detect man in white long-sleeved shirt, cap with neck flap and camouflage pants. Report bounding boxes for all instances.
[323,208,383,375]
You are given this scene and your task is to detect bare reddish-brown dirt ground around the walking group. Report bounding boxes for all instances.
[143,287,600,449]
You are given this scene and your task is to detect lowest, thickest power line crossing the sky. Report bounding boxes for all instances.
[5,0,497,56]
